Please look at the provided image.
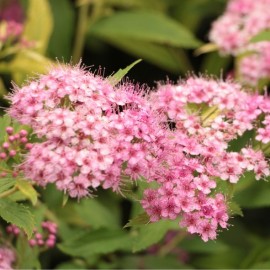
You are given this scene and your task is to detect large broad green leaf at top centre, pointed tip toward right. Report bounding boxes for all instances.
[88,11,201,48]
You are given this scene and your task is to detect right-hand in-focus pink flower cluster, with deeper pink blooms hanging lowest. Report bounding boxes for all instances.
[142,78,270,241]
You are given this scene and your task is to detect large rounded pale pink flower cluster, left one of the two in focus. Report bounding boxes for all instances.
[9,66,165,198]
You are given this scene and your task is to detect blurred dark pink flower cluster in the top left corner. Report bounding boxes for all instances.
[0,0,23,43]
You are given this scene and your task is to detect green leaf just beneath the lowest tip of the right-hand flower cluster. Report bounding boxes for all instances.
[133,220,179,252]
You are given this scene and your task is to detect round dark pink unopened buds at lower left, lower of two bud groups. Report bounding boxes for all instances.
[6,221,57,248]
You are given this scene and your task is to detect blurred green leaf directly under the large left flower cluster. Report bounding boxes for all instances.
[74,198,120,229]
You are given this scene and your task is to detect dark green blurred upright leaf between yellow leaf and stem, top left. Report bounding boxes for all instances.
[48,0,75,61]
